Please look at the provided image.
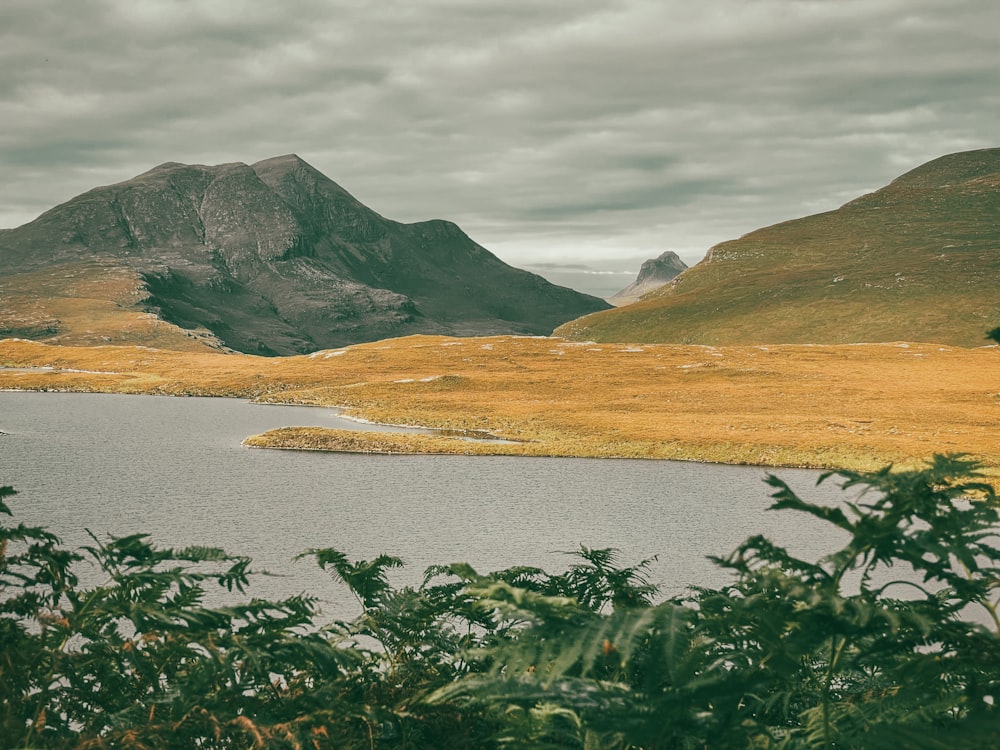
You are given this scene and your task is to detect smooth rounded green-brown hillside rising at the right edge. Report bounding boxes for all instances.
[555,148,1000,346]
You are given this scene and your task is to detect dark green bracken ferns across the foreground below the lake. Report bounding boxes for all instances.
[0,455,1000,750]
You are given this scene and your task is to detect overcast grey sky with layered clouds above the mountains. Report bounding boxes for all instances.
[0,0,1000,296]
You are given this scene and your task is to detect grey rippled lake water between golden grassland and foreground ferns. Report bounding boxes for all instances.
[0,392,840,615]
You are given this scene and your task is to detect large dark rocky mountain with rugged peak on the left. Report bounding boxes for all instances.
[0,155,608,355]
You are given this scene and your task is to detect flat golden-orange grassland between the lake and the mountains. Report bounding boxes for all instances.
[0,336,1000,476]
